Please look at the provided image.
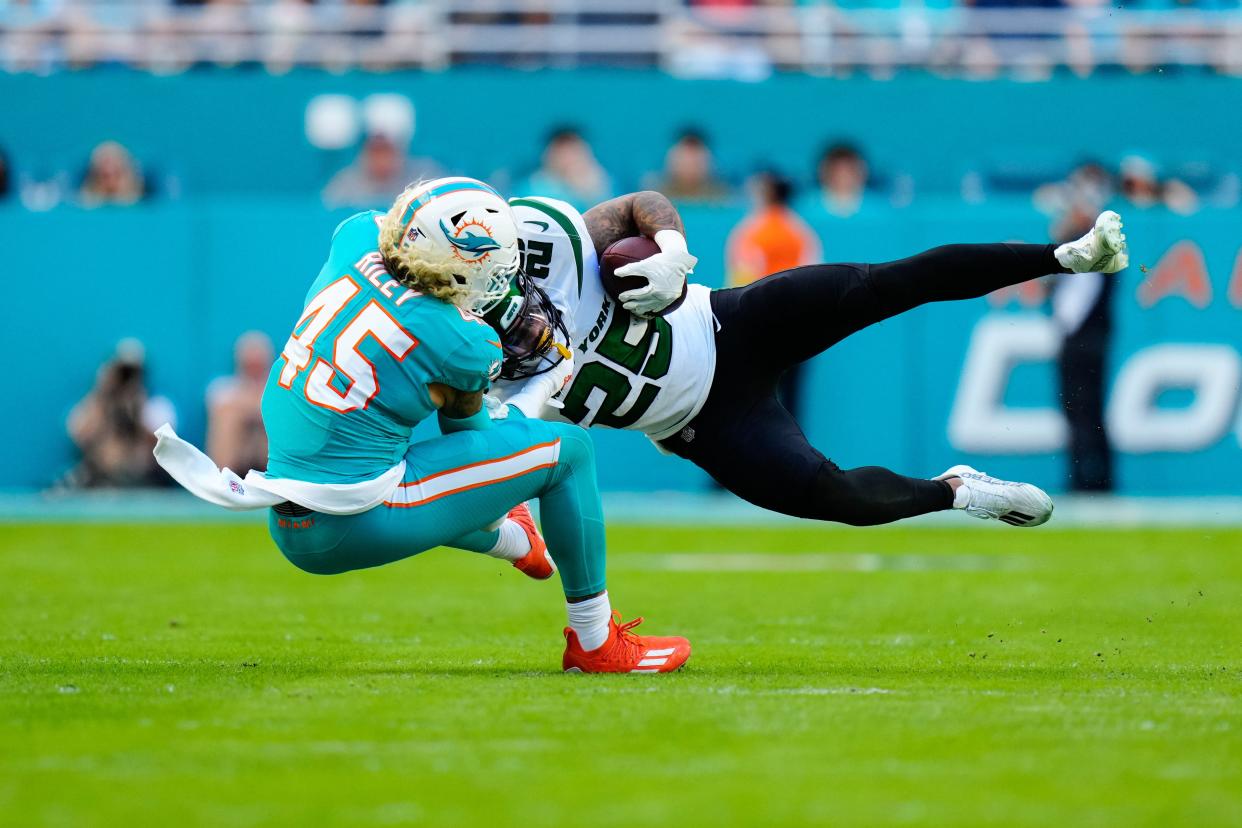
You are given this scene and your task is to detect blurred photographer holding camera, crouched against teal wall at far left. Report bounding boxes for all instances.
[67,339,176,488]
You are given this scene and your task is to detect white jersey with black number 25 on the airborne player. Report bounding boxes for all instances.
[498,197,715,439]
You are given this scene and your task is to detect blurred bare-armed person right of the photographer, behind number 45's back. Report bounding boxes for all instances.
[207,330,274,469]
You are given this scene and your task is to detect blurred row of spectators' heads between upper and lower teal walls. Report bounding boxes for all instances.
[0,125,1242,215]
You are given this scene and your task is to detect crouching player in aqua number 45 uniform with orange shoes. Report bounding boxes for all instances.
[155,178,691,673]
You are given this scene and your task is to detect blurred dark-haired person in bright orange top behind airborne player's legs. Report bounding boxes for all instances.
[725,171,823,418]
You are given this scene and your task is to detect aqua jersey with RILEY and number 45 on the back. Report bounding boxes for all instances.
[263,211,501,483]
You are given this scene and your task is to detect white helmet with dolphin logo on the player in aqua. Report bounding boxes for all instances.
[381,176,522,312]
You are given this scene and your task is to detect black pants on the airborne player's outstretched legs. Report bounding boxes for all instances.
[661,245,1063,526]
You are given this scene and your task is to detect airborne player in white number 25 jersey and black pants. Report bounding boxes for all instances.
[483,191,1128,526]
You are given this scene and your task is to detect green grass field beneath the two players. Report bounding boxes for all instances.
[0,525,1242,827]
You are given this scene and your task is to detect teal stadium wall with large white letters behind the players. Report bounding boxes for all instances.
[0,71,1242,494]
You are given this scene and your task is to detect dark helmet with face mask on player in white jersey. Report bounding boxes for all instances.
[483,271,569,380]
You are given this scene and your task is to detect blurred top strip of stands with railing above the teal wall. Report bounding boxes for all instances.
[0,0,1242,79]
